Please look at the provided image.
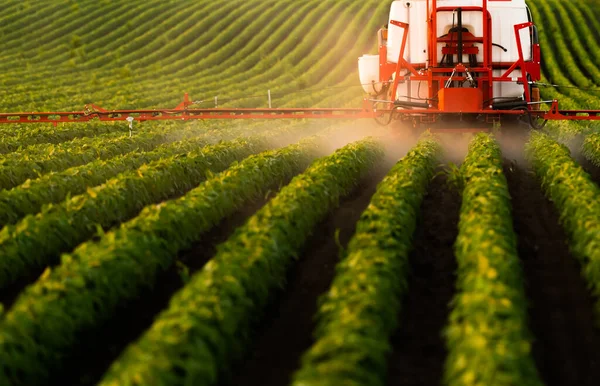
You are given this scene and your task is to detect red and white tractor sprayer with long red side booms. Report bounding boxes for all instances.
[0,0,600,131]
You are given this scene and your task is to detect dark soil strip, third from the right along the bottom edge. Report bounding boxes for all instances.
[223,172,385,386]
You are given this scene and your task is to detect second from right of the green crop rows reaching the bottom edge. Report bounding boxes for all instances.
[292,134,441,386]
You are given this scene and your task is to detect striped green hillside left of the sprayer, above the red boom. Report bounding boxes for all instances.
[0,0,389,111]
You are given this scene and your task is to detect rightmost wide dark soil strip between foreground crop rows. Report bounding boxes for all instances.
[504,162,600,386]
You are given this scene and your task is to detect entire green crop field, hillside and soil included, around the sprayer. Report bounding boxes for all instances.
[0,0,600,386]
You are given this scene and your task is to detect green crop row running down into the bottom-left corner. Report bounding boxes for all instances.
[0,136,324,385]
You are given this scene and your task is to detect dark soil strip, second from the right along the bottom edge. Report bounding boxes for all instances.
[388,174,461,386]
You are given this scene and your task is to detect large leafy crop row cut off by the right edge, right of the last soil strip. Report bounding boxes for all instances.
[526,132,600,322]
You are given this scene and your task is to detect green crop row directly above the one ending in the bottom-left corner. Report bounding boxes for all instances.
[0,139,268,288]
